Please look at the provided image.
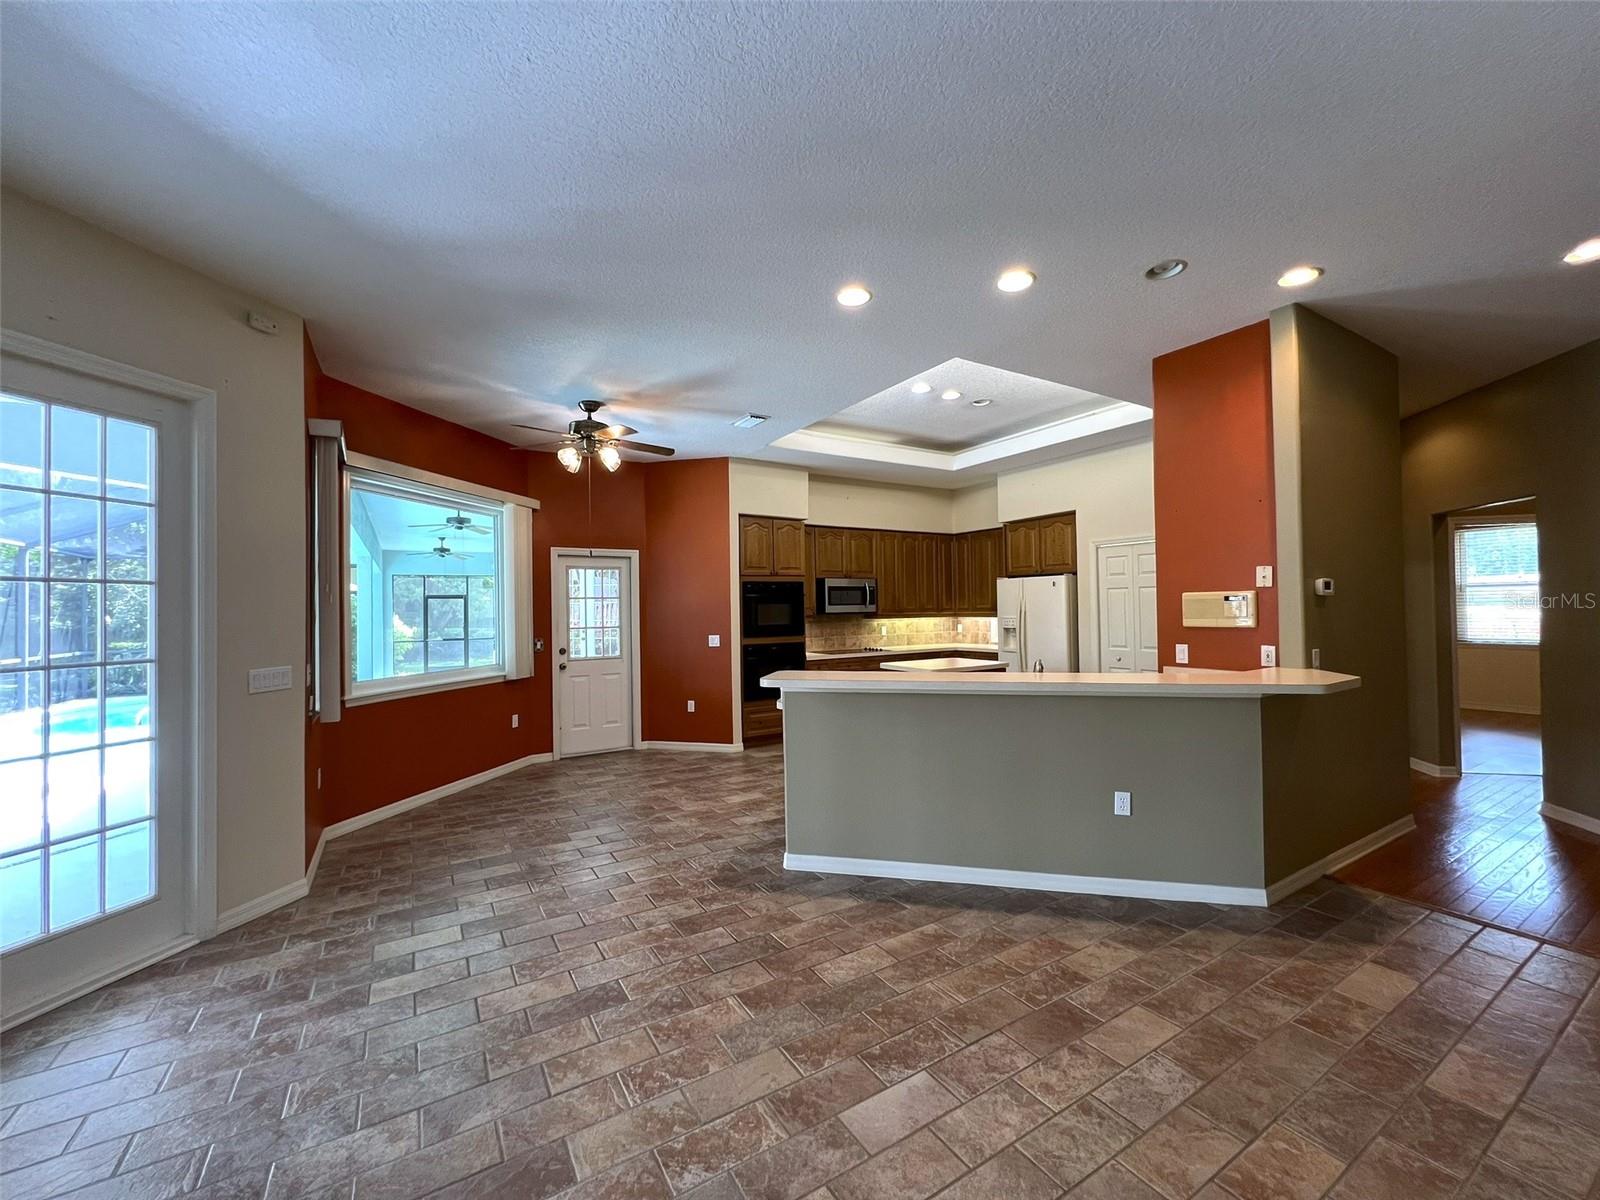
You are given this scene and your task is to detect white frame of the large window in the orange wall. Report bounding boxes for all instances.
[338,454,538,707]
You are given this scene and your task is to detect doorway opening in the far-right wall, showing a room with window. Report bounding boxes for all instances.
[1446,498,1544,776]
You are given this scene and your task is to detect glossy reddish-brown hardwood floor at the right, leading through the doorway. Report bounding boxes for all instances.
[1336,773,1600,954]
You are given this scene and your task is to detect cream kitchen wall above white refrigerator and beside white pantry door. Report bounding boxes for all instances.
[995,438,1162,670]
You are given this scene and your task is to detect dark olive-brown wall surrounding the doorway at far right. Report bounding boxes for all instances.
[1400,341,1600,818]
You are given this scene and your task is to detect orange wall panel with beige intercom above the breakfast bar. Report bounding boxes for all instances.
[1152,322,1278,670]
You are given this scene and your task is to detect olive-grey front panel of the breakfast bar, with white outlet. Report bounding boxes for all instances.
[784,691,1267,888]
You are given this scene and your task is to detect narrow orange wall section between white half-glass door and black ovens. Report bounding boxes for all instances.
[640,459,736,742]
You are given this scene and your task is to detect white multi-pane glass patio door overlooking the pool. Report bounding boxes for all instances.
[0,380,194,1024]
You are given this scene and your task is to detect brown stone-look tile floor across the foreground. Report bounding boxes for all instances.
[0,749,1600,1200]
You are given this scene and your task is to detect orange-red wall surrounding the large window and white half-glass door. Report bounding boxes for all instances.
[306,344,733,859]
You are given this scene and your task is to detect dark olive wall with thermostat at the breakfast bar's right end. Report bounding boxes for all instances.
[1267,304,1410,857]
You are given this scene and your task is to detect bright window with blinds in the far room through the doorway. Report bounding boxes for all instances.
[1454,522,1539,646]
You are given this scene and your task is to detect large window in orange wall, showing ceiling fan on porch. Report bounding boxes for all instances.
[347,470,510,696]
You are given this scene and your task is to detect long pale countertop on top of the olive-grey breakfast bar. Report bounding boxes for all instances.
[762,667,1362,699]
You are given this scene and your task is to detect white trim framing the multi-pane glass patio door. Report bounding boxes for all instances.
[0,330,218,1024]
